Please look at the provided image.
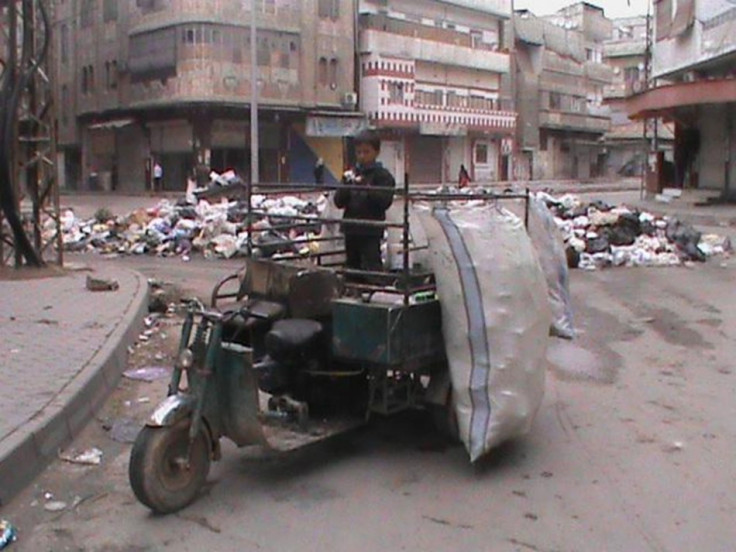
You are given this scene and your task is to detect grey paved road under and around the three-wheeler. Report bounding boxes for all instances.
[2,261,736,552]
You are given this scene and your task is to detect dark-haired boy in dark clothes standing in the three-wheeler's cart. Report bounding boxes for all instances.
[335,130,396,272]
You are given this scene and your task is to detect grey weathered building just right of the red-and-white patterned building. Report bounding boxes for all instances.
[514,3,613,179]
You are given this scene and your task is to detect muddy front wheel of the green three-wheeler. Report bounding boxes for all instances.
[128,419,211,514]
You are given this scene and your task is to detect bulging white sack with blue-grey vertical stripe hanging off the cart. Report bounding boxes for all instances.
[421,205,551,462]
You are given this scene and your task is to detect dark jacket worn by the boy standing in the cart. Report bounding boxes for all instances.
[335,163,396,237]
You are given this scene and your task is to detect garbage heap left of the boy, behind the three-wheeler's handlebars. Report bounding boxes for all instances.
[61,195,327,261]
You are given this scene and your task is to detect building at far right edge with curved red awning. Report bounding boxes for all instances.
[627,0,736,198]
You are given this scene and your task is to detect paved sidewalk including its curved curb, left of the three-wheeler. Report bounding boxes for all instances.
[0,268,148,505]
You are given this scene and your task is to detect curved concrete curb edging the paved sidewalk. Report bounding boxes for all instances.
[0,271,148,506]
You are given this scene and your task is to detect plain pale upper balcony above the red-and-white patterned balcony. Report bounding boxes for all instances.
[360,29,510,73]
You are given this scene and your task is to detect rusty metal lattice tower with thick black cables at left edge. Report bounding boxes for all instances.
[0,0,63,267]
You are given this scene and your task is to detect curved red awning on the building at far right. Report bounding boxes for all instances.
[626,79,736,119]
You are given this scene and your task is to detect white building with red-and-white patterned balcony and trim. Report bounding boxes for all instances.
[358,0,516,183]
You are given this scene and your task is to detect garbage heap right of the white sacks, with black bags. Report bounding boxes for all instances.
[537,192,731,270]
